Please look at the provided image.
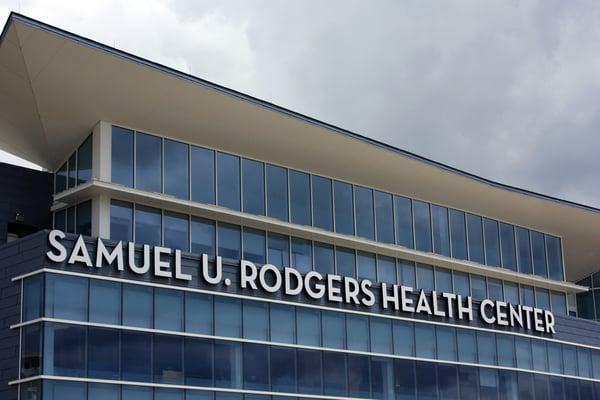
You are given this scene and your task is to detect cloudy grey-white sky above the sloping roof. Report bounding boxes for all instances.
[0,0,600,206]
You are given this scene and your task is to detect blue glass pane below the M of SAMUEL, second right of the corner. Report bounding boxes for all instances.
[89,279,121,325]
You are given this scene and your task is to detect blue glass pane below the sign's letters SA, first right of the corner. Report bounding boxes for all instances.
[45,274,88,321]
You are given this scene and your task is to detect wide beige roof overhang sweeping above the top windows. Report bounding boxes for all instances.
[0,14,600,281]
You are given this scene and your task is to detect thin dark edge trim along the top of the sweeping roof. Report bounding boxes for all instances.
[0,11,600,213]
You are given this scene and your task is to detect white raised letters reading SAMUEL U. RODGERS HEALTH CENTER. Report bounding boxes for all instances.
[46,230,555,333]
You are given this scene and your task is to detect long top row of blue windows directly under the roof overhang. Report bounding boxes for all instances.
[110,127,564,280]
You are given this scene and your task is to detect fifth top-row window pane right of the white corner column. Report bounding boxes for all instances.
[217,153,240,210]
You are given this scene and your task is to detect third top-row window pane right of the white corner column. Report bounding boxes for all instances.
[164,139,190,199]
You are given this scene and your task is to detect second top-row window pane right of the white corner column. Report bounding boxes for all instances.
[135,132,162,192]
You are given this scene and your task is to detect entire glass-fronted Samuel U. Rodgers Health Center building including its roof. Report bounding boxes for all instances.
[0,10,600,400]
